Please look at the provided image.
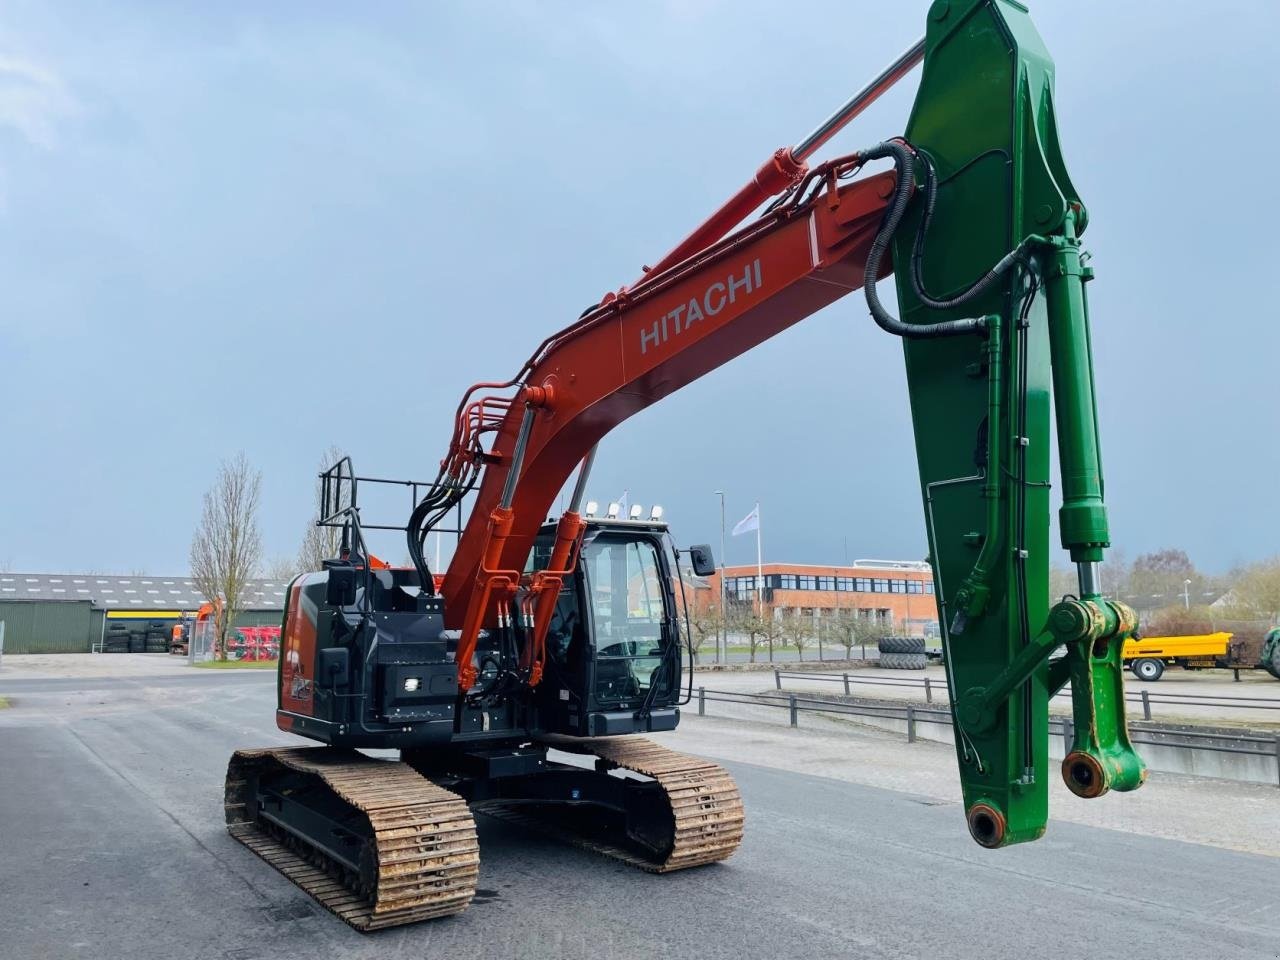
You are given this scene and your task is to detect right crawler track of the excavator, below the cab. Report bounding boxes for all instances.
[477,736,746,873]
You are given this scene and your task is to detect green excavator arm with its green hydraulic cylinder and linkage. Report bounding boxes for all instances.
[892,0,1146,846]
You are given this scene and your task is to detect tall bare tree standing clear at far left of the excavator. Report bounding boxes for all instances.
[191,452,262,660]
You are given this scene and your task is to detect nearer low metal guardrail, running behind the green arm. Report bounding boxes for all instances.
[698,686,1280,787]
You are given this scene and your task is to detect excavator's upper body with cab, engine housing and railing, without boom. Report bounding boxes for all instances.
[268,457,696,754]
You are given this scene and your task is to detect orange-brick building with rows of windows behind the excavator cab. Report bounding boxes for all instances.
[708,559,938,636]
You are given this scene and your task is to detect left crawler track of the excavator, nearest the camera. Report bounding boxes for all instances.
[225,748,480,931]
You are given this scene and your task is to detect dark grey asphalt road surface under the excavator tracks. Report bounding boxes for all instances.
[0,673,1280,960]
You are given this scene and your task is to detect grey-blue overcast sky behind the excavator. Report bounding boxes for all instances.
[0,0,1280,572]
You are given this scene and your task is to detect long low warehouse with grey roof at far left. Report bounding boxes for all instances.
[0,573,288,653]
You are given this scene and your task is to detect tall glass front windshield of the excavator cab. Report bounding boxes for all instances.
[581,535,666,704]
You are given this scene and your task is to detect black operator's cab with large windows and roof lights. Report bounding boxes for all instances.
[529,518,681,736]
